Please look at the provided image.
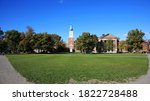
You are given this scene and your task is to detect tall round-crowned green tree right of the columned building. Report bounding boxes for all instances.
[127,29,145,52]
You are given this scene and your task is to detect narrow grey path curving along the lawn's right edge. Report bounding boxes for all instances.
[130,54,150,84]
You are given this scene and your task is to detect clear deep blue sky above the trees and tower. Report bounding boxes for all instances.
[0,0,150,42]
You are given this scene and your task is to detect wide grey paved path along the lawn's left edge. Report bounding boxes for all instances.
[0,55,29,84]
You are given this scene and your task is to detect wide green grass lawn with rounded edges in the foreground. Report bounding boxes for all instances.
[7,54,148,83]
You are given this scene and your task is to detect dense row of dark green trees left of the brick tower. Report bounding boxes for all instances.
[0,26,68,54]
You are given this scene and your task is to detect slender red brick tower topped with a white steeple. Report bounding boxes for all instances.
[68,25,74,52]
